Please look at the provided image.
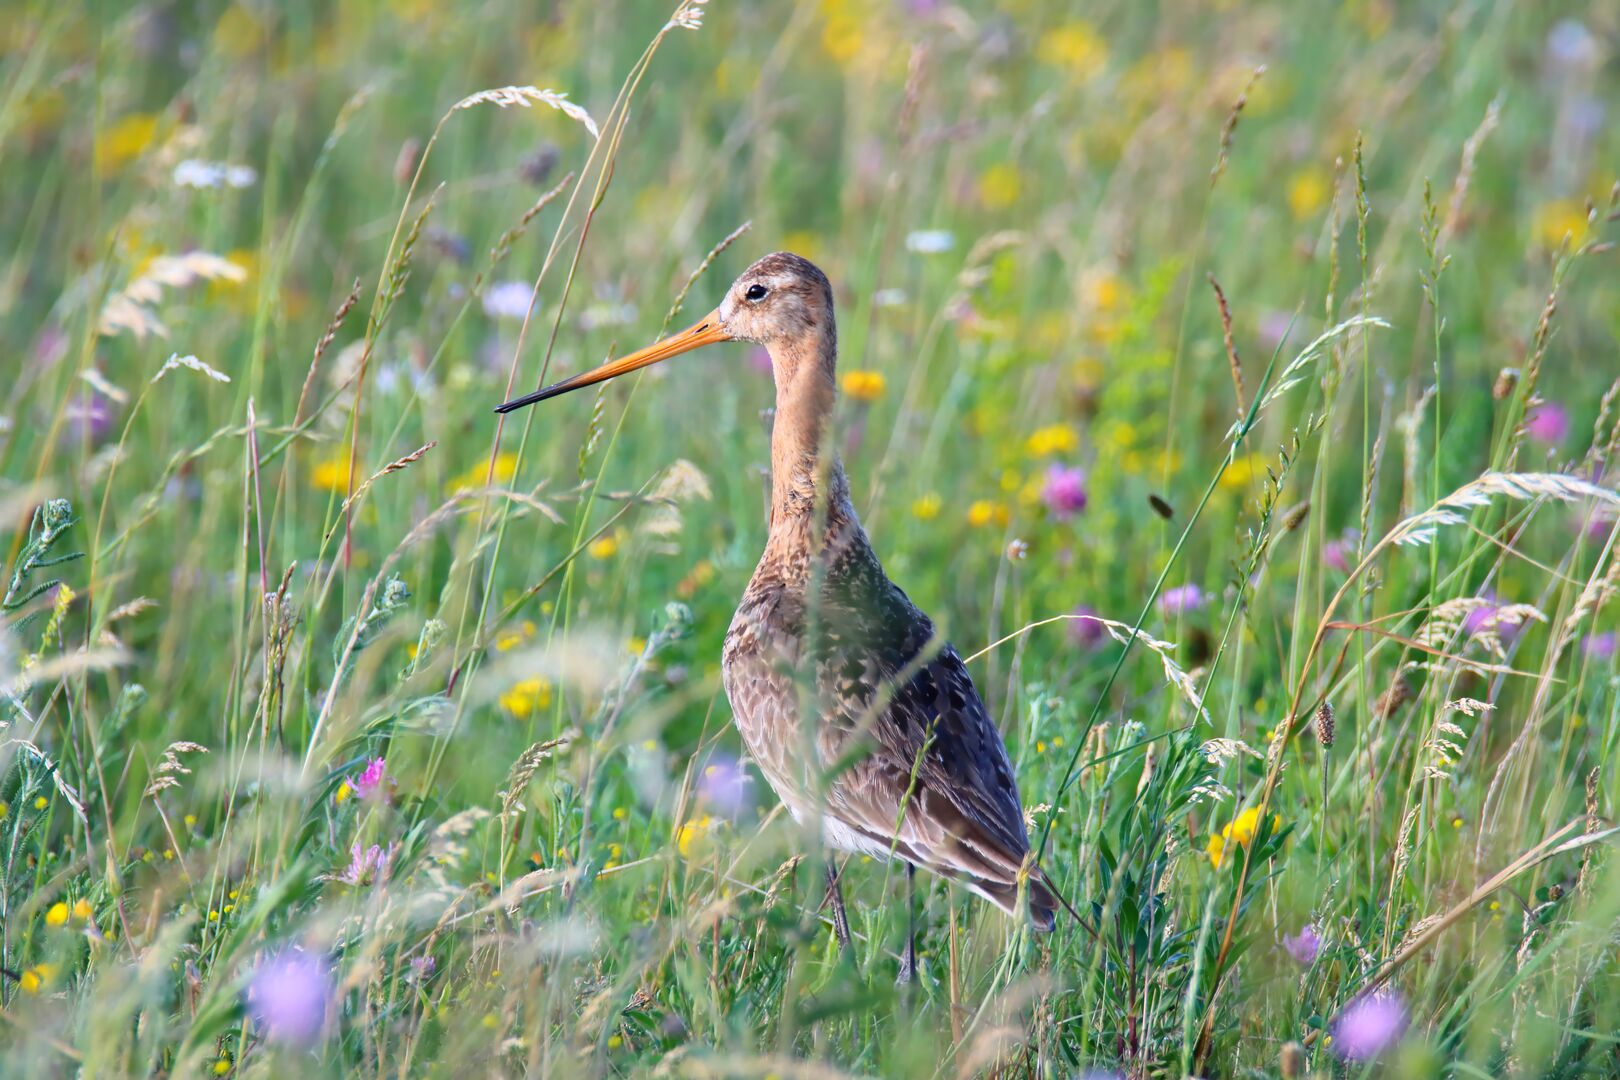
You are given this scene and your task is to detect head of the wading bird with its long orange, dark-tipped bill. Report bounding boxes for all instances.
[496,251,834,413]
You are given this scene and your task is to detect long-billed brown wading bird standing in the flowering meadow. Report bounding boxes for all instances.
[496,251,1072,983]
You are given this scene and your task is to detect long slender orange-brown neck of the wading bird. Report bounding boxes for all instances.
[768,334,859,547]
